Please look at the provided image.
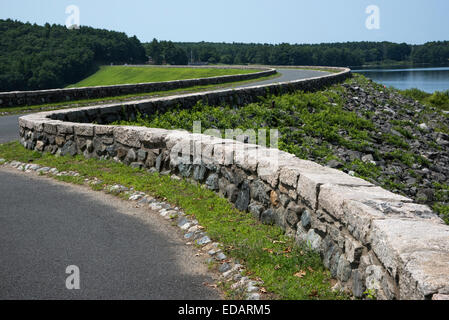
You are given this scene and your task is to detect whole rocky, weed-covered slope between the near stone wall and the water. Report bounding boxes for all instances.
[114,75,449,223]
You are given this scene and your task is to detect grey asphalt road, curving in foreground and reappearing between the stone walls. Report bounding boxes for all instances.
[0,69,328,300]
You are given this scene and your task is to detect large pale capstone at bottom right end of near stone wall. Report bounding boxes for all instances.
[370,219,449,299]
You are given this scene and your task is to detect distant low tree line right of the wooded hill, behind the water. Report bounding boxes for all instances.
[144,39,449,66]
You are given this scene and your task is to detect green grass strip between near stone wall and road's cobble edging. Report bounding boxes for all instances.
[0,142,348,300]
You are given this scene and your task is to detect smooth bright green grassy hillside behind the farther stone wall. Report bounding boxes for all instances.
[69,66,256,88]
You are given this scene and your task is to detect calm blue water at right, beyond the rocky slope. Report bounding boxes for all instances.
[353,67,449,93]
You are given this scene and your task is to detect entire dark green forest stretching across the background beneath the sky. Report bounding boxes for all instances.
[0,19,449,91]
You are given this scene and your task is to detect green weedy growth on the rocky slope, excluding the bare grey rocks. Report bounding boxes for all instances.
[114,75,449,225]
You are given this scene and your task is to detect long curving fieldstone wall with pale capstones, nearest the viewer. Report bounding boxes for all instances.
[19,70,449,299]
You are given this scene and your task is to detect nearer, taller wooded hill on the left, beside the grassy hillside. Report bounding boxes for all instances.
[0,19,147,91]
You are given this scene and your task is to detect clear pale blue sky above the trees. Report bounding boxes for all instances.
[0,0,449,44]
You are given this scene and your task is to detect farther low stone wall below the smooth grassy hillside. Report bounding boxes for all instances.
[0,66,276,108]
